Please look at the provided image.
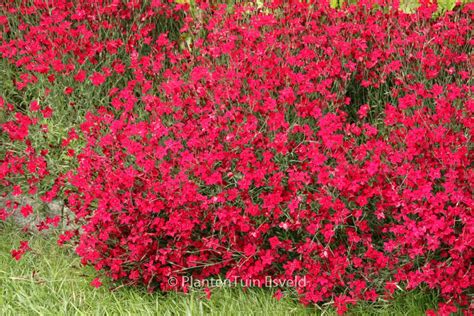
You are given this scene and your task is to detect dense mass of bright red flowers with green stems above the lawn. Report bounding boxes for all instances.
[0,0,474,315]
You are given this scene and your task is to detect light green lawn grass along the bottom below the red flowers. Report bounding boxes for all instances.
[0,223,444,315]
